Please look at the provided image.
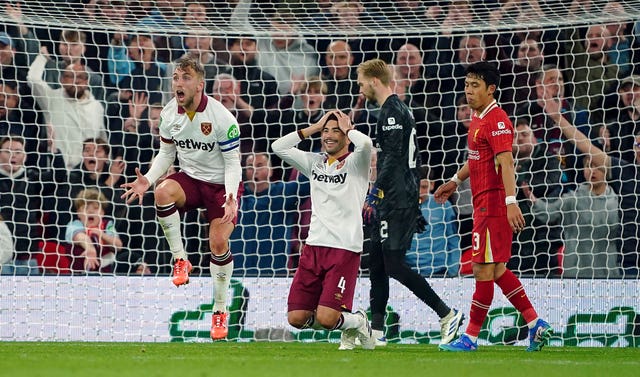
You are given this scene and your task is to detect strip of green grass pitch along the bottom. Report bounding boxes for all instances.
[0,342,640,377]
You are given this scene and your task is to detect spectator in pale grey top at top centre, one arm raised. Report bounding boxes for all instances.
[230,0,320,94]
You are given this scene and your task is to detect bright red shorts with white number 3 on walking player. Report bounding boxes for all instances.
[471,216,513,263]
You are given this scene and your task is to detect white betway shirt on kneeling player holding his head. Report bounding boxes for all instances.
[272,130,373,253]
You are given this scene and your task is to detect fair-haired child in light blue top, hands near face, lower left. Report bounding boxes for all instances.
[65,189,122,272]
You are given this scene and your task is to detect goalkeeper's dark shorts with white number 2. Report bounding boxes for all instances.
[371,208,417,252]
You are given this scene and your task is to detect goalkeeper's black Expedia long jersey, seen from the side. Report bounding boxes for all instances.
[376,94,420,212]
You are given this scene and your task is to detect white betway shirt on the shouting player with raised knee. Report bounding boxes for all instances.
[159,95,242,195]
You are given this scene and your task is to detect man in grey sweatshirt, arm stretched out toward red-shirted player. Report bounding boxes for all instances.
[523,156,620,278]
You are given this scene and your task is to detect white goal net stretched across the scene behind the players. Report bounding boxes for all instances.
[0,0,640,346]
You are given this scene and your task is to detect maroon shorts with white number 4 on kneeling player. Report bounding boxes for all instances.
[287,245,360,311]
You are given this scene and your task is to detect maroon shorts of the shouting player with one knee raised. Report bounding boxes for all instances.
[167,172,244,224]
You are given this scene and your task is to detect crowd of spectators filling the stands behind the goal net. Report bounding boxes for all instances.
[0,0,640,278]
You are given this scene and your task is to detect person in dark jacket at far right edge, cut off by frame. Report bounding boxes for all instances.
[604,75,640,161]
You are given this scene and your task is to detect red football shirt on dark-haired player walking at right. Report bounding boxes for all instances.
[467,101,514,216]
